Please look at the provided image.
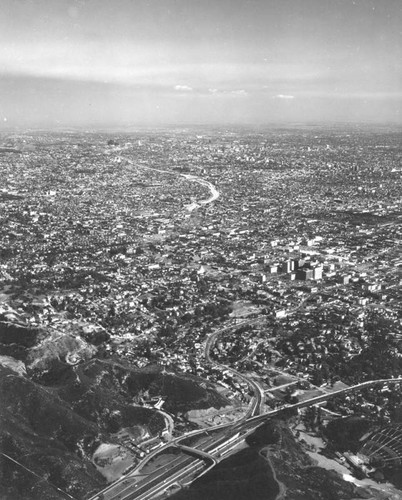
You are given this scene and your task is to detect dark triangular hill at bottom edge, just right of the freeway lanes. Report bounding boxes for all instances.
[171,420,360,500]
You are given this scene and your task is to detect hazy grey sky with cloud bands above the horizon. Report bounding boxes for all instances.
[0,0,402,127]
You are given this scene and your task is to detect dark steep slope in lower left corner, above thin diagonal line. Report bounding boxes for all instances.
[0,367,104,500]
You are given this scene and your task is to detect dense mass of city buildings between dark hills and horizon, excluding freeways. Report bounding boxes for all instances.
[0,130,402,428]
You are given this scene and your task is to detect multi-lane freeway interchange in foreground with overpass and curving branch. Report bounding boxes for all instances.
[90,312,402,500]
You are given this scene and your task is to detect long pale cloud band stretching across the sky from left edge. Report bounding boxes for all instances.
[0,40,325,96]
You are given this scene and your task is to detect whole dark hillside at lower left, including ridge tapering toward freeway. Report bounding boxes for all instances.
[0,359,228,500]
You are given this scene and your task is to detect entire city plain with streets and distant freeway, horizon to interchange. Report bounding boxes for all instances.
[0,126,402,498]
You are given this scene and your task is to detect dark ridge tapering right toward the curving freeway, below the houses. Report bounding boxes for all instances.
[51,359,229,423]
